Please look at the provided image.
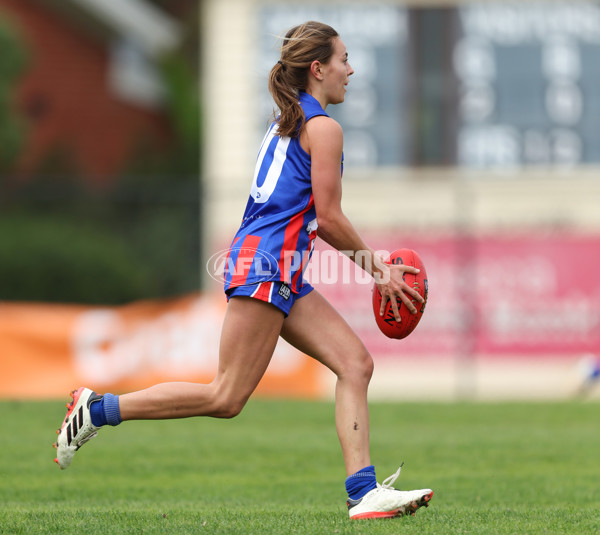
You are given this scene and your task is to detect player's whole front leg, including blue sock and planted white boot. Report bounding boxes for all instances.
[281,290,433,519]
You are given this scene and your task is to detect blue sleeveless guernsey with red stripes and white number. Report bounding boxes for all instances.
[224,92,328,293]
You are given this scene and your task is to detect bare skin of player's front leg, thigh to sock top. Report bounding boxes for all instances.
[281,290,373,475]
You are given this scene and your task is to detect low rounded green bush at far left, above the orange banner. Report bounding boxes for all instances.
[0,214,151,304]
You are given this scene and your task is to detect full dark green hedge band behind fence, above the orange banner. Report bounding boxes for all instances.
[0,178,200,304]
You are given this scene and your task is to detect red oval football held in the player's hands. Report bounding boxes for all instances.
[373,249,428,339]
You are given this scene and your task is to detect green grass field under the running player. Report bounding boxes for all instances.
[0,399,600,535]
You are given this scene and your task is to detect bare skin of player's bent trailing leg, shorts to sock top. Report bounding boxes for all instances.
[119,297,284,420]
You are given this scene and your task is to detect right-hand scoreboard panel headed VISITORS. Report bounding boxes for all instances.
[452,2,600,166]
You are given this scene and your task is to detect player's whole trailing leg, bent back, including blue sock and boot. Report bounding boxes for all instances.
[54,297,284,469]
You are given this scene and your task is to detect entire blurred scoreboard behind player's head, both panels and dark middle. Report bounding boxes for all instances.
[259,1,600,168]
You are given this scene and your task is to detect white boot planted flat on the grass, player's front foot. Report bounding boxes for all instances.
[347,463,433,520]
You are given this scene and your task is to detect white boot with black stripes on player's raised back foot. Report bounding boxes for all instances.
[53,387,102,470]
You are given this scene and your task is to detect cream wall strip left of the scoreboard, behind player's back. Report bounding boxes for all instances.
[201,0,257,264]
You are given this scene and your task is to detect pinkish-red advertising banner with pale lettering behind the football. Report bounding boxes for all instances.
[307,231,600,358]
